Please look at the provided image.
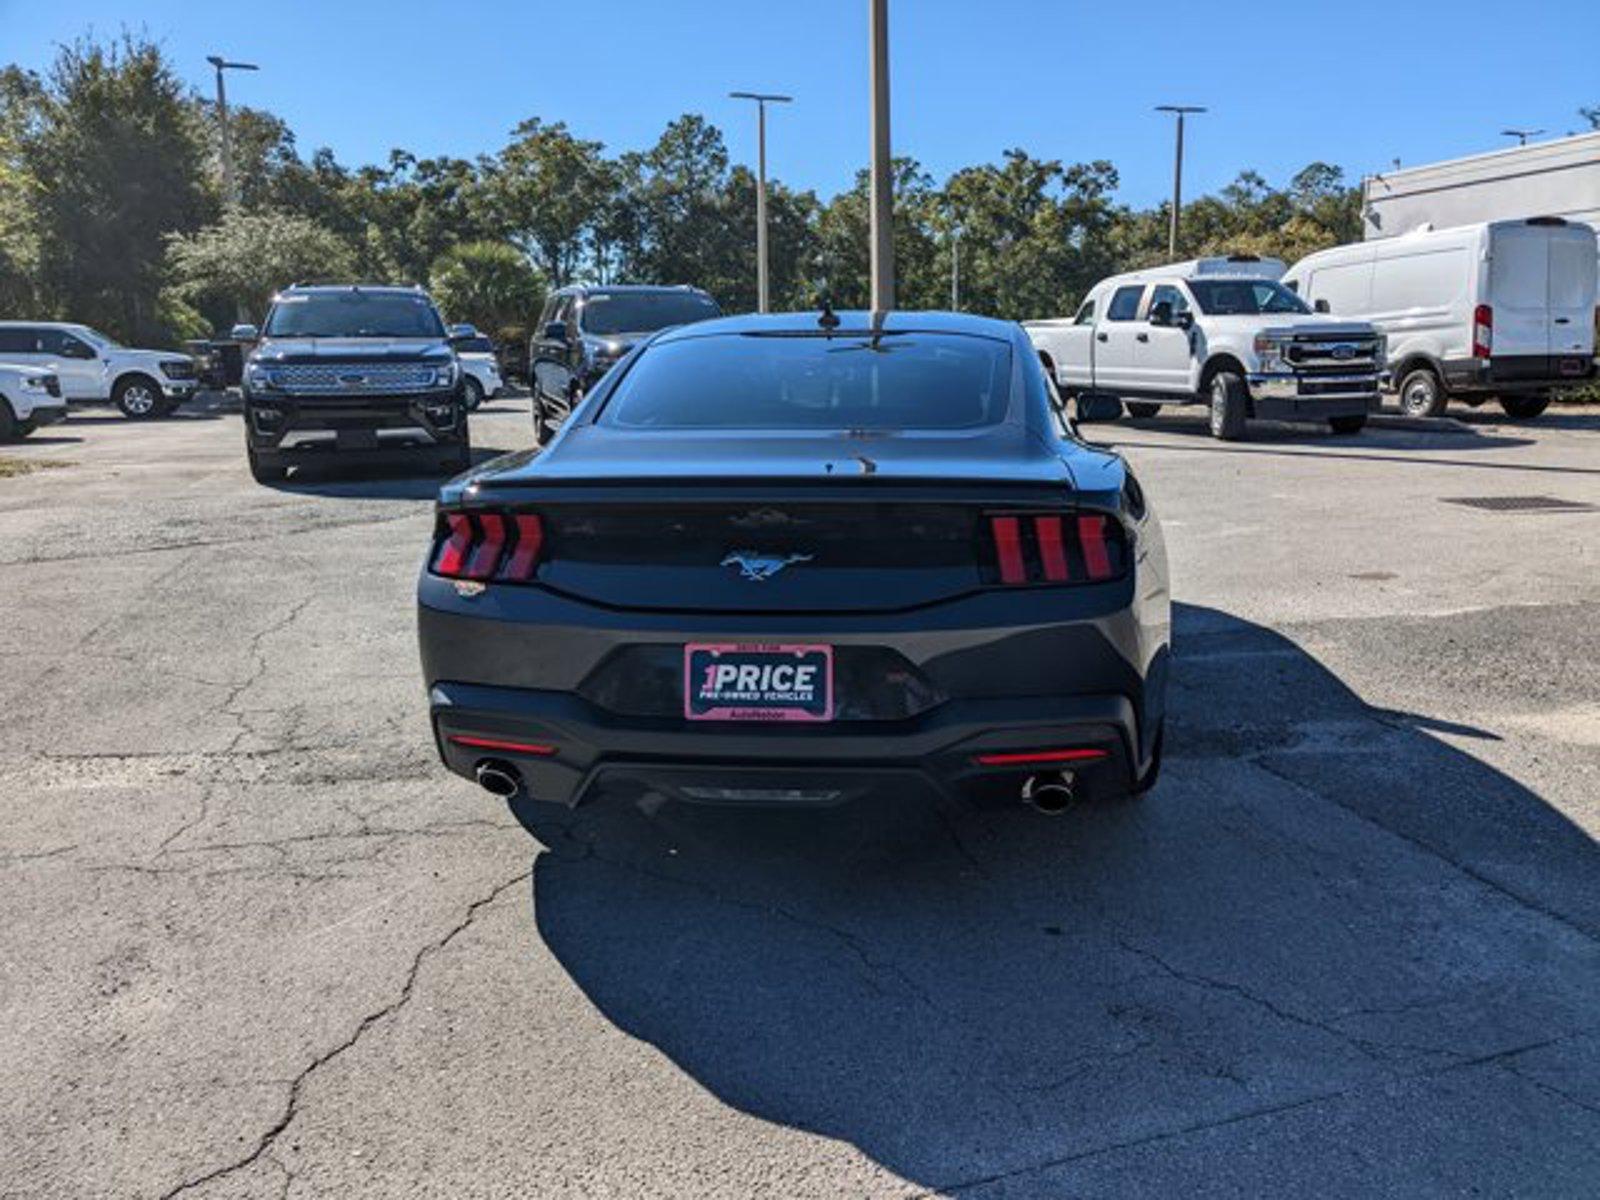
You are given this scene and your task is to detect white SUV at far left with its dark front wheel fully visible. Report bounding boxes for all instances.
[0,322,198,418]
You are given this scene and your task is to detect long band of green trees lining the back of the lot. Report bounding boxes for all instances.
[0,37,1376,339]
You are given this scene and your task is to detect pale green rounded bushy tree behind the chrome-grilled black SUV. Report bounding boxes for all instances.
[166,208,354,326]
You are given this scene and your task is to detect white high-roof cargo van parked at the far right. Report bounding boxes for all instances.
[1283,216,1600,418]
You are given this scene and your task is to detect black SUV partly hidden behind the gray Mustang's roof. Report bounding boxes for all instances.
[528,283,722,446]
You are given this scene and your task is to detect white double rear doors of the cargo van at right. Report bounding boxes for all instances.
[1483,218,1595,358]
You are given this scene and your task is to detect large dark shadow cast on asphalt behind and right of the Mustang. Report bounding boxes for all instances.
[515,606,1600,1197]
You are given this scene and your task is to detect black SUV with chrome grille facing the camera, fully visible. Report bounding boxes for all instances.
[234,283,472,483]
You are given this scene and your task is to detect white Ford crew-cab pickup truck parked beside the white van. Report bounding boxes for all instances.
[1022,254,1384,440]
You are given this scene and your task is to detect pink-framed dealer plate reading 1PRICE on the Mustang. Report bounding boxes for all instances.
[683,642,834,723]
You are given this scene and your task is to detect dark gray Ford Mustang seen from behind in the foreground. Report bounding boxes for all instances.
[418,312,1171,811]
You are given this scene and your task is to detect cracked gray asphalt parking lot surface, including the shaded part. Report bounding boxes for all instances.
[0,402,1600,1200]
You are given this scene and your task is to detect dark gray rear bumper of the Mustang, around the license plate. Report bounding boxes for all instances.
[418,574,1168,806]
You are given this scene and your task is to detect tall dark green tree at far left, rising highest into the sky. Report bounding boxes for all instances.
[19,35,213,339]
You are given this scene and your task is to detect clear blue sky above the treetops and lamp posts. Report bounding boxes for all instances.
[0,0,1600,205]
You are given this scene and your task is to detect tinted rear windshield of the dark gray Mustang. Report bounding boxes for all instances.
[600,333,1011,429]
